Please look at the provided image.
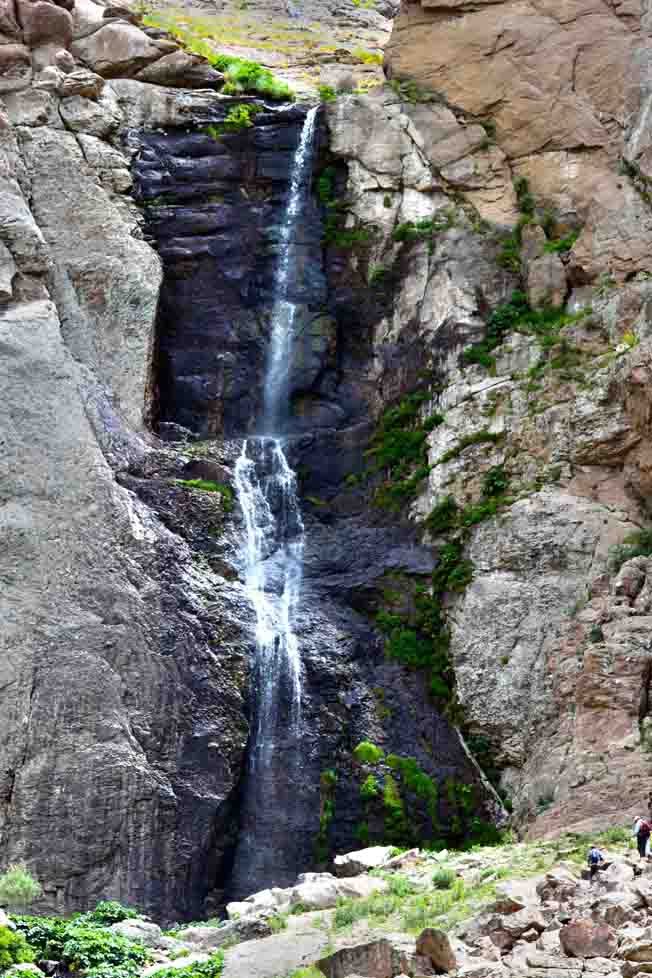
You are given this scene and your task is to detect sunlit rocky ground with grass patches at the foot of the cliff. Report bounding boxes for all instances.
[12,829,652,978]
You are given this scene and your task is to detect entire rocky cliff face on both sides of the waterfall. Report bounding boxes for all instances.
[0,0,652,920]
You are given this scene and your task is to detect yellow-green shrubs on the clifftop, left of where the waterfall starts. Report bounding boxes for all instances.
[143,11,294,101]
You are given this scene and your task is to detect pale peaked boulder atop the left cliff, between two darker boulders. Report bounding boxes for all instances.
[72,21,166,78]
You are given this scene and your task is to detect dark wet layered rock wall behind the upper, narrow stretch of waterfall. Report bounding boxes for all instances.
[136,109,352,437]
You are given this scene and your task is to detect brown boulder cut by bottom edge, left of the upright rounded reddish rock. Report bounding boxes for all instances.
[317,938,435,978]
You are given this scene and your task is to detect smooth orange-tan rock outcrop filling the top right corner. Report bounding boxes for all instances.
[386,0,652,282]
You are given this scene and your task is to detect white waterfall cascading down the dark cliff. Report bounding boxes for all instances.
[231,108,318,895]
